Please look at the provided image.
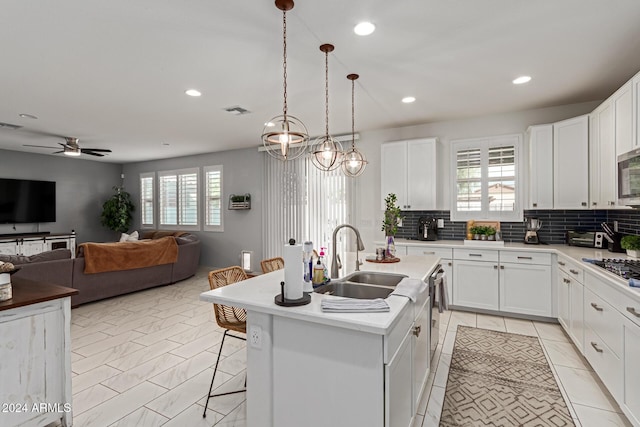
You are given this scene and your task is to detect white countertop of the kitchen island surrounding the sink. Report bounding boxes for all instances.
[200,254,440,335]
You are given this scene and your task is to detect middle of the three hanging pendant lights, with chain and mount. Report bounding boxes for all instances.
[311,44,342,172]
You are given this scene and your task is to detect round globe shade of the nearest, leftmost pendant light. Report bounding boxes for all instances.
[262,115,309,161]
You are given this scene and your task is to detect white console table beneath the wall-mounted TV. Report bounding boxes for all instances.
[0,231,76,258]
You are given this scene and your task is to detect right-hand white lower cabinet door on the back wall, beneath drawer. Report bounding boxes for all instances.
[499,261,552,317]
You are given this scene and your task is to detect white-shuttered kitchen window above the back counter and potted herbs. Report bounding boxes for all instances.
[451,135,522,221]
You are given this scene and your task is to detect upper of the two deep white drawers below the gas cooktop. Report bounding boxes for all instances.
[584,288,623,357]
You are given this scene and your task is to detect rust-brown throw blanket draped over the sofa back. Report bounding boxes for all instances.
[79,237,178,274]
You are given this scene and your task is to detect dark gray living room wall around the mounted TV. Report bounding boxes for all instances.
[0,150,122,243]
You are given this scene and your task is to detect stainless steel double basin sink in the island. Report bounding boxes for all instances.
[314,271,407,299]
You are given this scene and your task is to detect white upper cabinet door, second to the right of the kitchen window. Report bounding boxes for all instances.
[553,115,589,209]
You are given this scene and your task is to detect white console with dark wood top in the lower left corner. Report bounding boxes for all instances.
[0,278,78,427]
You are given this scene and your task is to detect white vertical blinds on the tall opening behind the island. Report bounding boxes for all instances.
[262,154,355,262]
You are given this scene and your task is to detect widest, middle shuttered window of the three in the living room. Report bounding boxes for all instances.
[158,169,199,230]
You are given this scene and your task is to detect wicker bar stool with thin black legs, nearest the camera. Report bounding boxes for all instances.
[202,266,247,418]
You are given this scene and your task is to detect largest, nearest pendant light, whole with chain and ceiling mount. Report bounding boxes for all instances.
[262,0,309,161]
